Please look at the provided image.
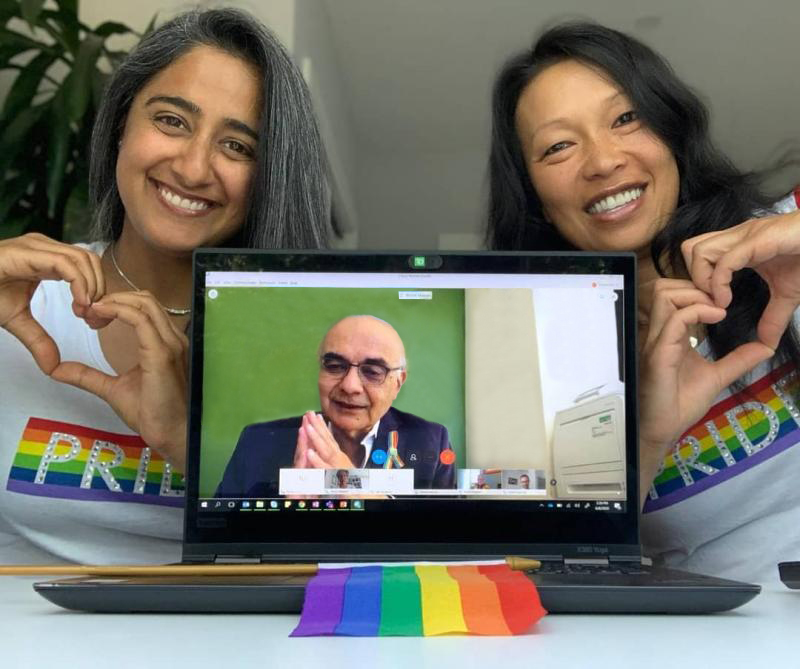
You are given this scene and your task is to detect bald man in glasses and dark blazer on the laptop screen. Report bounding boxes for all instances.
[216,316,455,497]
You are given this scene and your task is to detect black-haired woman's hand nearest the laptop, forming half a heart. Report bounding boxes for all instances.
[639,279,774,504]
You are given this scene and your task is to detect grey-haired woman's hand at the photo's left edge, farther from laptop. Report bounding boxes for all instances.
[0,233,109,374]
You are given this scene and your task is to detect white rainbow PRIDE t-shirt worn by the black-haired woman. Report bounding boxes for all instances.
[641,185,800,583]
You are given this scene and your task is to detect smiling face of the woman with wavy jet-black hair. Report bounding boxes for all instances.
[515,60,679,252]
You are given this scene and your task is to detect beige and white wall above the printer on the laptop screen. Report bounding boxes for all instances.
[465,287,622,470]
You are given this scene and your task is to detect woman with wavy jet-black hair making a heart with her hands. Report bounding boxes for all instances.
[487,23,800,578]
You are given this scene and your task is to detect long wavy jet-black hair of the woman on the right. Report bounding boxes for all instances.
[486,23,800,376]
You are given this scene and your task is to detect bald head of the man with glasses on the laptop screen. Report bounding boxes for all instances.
[318,316,406,440]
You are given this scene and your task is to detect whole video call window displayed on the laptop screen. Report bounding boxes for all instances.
[200,272,626,501]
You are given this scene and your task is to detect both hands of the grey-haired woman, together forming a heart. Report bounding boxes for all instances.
[0,234,189,471]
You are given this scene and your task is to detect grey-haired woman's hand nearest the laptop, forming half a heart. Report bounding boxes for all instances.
[51,291,189,472]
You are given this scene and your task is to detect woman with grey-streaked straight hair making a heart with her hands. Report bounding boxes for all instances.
[0,9,329,562]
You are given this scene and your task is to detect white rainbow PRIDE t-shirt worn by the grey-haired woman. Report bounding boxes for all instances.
[0,244,183,564]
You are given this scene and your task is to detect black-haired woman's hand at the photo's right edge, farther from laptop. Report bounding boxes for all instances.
[681,212,800,350]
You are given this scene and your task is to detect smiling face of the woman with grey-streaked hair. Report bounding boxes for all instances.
[116,46,261,255]
